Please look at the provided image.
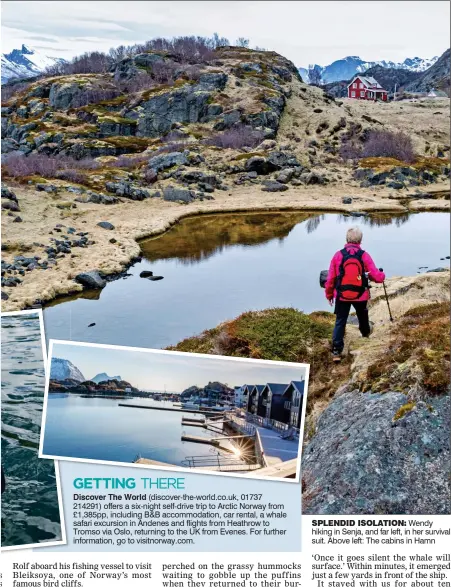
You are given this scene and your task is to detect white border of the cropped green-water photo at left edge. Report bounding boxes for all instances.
[0,309,67,552]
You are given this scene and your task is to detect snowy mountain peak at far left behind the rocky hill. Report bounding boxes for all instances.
[2,44,65,84]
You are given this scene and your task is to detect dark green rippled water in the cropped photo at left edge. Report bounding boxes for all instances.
[1,315,61,546]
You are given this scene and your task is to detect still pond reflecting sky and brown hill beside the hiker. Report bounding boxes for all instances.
[44,212,450,348]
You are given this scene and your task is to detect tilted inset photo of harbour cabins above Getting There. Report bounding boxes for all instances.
[40,341,309,481]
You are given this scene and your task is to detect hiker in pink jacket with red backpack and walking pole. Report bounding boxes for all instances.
[326,228,385,362]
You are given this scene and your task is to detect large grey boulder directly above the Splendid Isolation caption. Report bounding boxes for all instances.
[302,391,451,515]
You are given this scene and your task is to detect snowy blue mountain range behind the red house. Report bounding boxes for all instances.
[299,55,438,84]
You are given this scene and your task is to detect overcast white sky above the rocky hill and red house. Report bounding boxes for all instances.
[2,0,450,67]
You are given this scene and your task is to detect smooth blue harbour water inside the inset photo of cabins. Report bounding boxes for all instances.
[43,393,242,466]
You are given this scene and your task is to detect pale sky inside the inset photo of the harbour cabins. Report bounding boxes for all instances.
[52,343,305,393]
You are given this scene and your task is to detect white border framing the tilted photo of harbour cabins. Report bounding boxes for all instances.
[39,339,310,483]
